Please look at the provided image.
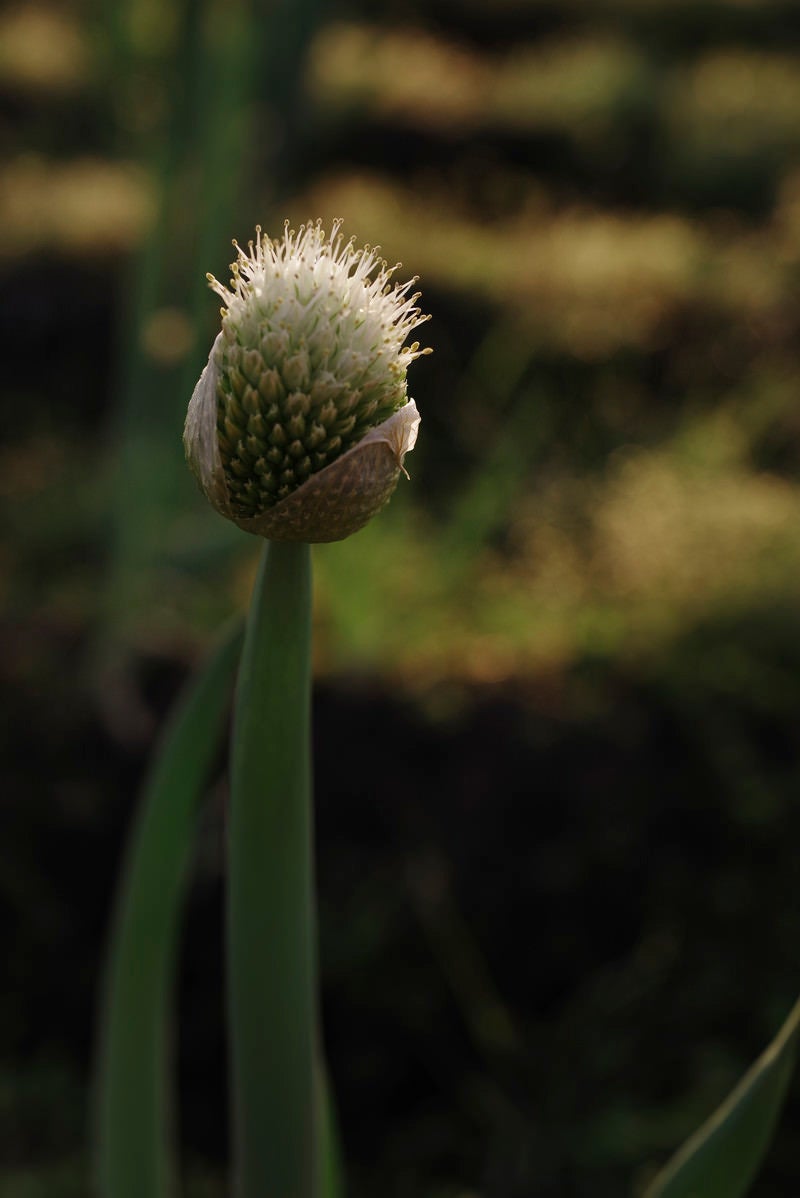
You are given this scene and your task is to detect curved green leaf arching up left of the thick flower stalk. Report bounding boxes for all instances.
[96,619,242,1198]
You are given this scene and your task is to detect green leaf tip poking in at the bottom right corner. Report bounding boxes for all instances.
[644,999,800,1198]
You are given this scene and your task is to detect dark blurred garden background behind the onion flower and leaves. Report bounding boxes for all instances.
[0,0,800,1198]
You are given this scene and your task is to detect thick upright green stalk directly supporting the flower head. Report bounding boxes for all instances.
[228,541,319,1198]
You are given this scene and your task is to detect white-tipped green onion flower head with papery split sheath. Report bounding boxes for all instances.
[183,222,430,541]
